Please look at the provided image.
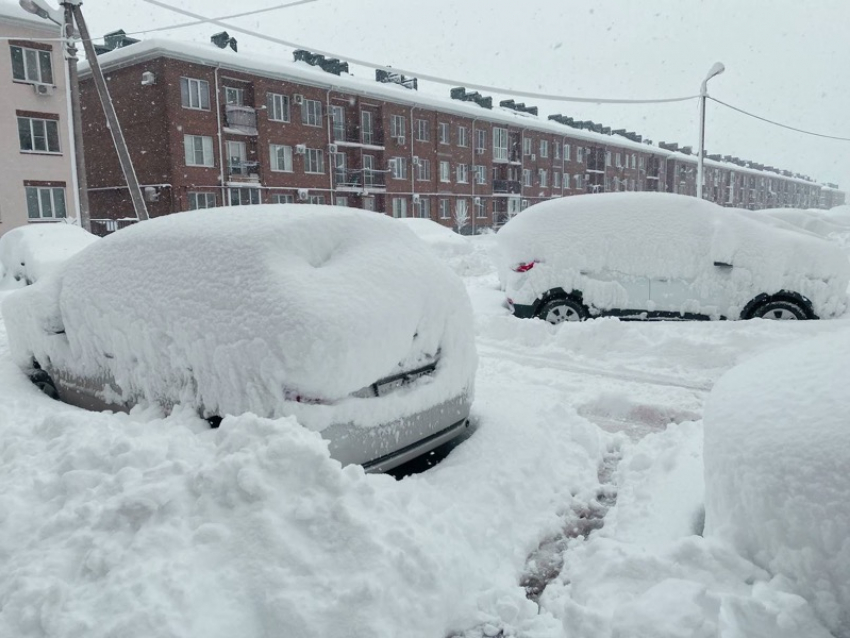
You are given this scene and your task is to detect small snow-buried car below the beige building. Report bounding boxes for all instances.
[0,223,98,288]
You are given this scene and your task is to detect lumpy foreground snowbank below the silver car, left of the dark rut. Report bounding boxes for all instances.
[0,320,602,638]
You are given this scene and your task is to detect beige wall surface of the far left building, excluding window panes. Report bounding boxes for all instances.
[0,6,77,236]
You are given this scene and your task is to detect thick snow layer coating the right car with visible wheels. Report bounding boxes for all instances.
[497,193,850,316]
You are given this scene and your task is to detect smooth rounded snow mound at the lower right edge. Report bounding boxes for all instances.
[705,329,850,636]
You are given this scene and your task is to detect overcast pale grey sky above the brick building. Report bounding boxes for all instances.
[83,0,850,189]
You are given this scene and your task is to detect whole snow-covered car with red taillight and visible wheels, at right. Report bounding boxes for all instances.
[497,193,850,323]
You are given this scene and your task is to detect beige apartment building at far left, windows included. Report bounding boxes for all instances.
[0,2,76,235]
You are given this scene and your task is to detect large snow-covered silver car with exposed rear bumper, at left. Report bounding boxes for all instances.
[2,205,477,471]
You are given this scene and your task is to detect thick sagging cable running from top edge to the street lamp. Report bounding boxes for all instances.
[137,0,699,104]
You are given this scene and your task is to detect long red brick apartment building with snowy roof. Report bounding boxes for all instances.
[81,32,843,233]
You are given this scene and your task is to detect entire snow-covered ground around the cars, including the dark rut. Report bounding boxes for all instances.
[0,229,850,638]
